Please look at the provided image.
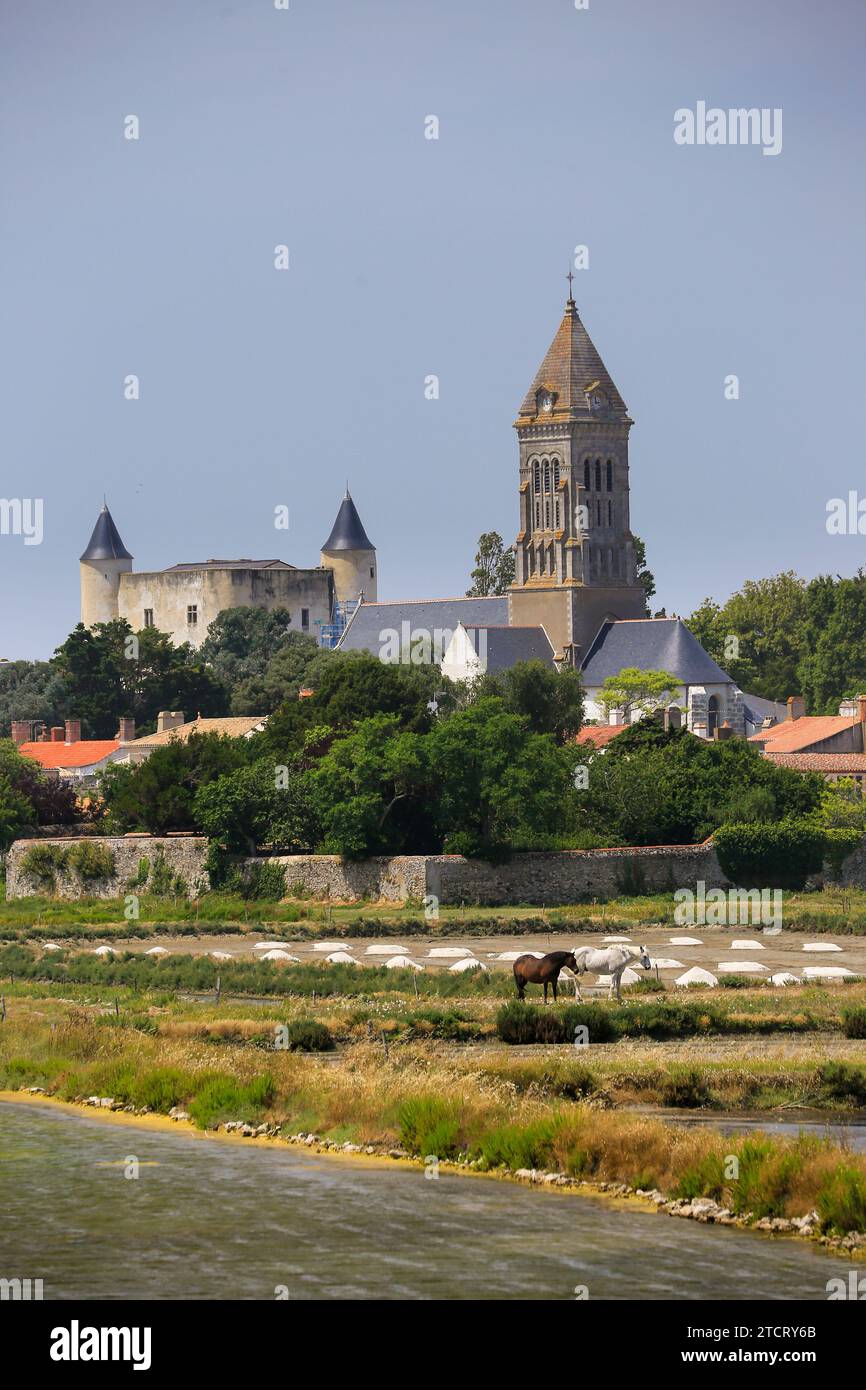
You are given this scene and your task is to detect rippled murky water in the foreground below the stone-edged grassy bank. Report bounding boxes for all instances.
[0,1104,840,1301]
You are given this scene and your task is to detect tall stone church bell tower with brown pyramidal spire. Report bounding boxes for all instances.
[509,287,646,664]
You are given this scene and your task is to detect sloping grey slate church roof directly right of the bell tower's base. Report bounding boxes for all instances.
[581,617,733,687]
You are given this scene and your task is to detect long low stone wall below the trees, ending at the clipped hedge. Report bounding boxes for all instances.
[254,842,728,906]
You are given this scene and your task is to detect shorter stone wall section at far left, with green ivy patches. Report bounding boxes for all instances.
[6,835,209,899]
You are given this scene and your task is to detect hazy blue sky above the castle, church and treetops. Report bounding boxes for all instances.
[0,0,866,657]
